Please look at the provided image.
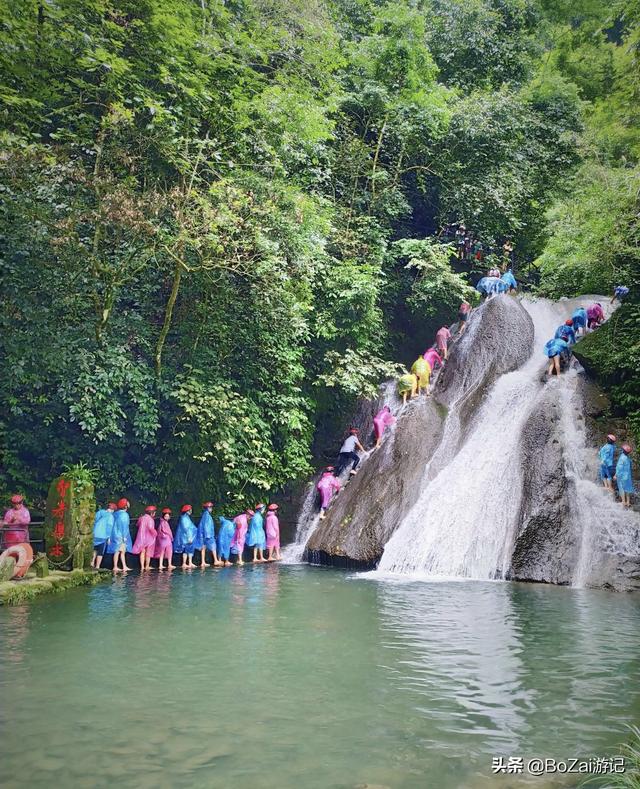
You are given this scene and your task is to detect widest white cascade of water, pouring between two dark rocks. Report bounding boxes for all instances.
[378,299,588,578]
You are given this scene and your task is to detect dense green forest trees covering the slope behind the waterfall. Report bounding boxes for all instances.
[0,0,638,500]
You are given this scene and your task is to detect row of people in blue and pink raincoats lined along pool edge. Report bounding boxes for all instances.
[91,498,281,573]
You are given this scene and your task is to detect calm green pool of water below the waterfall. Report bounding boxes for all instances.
[0,565,640,789]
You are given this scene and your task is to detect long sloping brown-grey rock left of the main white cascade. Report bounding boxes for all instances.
[302,296,533,568]
